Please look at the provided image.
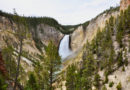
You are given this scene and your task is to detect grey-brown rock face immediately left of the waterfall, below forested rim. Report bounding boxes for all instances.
[32,24,64,46]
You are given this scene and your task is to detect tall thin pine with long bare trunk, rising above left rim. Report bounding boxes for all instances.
[14,14,28,90]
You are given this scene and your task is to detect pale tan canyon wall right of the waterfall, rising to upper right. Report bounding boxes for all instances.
[70,11,119,51]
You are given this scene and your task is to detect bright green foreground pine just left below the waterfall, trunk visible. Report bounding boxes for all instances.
[44,41,61,90]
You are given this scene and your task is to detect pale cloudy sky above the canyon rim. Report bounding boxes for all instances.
[0,0,120,25]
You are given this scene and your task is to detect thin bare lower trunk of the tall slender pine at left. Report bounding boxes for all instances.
[13,39,23,90]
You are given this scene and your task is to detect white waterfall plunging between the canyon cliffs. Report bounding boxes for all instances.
[59,35,72,60]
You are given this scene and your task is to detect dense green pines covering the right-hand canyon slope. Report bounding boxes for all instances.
[66,7,128,90]
